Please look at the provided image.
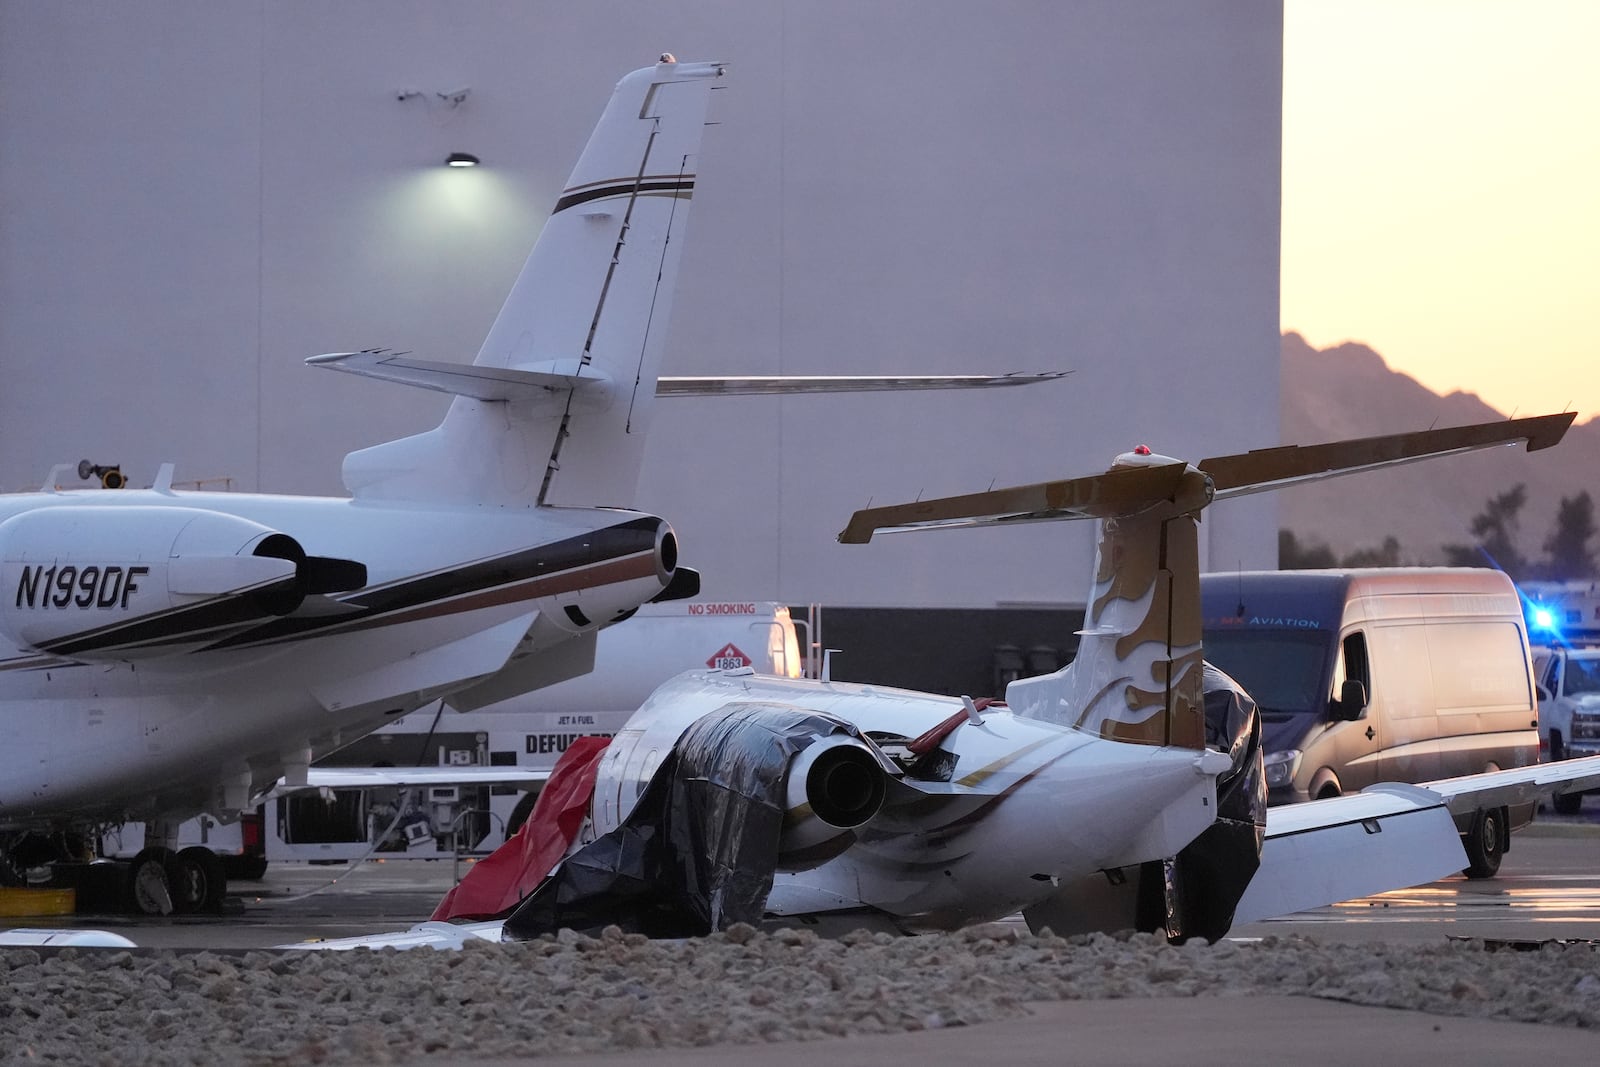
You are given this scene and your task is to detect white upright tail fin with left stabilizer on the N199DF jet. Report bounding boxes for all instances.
[337,56,723,506]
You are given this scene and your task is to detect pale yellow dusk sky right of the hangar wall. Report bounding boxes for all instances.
[1282,0,1600,419]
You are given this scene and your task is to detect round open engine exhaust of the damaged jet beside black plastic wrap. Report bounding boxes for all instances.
[778,734,888,870]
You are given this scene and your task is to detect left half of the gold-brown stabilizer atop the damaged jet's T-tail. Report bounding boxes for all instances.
[838,462,1187,544]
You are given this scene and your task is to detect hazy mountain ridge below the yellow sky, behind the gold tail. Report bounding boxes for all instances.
[1278,331,1600,563]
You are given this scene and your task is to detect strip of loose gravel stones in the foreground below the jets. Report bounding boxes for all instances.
[0,926,1600,1064]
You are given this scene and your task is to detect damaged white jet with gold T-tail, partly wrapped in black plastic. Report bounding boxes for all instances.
[291,414,1600,949]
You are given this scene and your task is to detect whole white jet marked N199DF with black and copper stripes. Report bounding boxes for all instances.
[0,54,1061,912]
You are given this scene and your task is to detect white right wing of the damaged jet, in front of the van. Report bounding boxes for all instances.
[1234,757,1600,926]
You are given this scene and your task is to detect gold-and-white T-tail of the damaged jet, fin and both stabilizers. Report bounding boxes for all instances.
[838,414,1574,749]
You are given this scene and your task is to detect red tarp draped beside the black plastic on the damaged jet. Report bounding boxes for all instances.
[432,737,611,920]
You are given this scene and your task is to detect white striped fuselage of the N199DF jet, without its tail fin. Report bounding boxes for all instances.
[0,491,674,827]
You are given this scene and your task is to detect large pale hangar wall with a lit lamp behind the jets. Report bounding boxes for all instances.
[0,0,1282,608]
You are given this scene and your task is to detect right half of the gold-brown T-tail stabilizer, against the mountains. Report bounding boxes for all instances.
[1198,411,1576,499]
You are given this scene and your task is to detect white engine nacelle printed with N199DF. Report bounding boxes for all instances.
[0,506,366,661]
